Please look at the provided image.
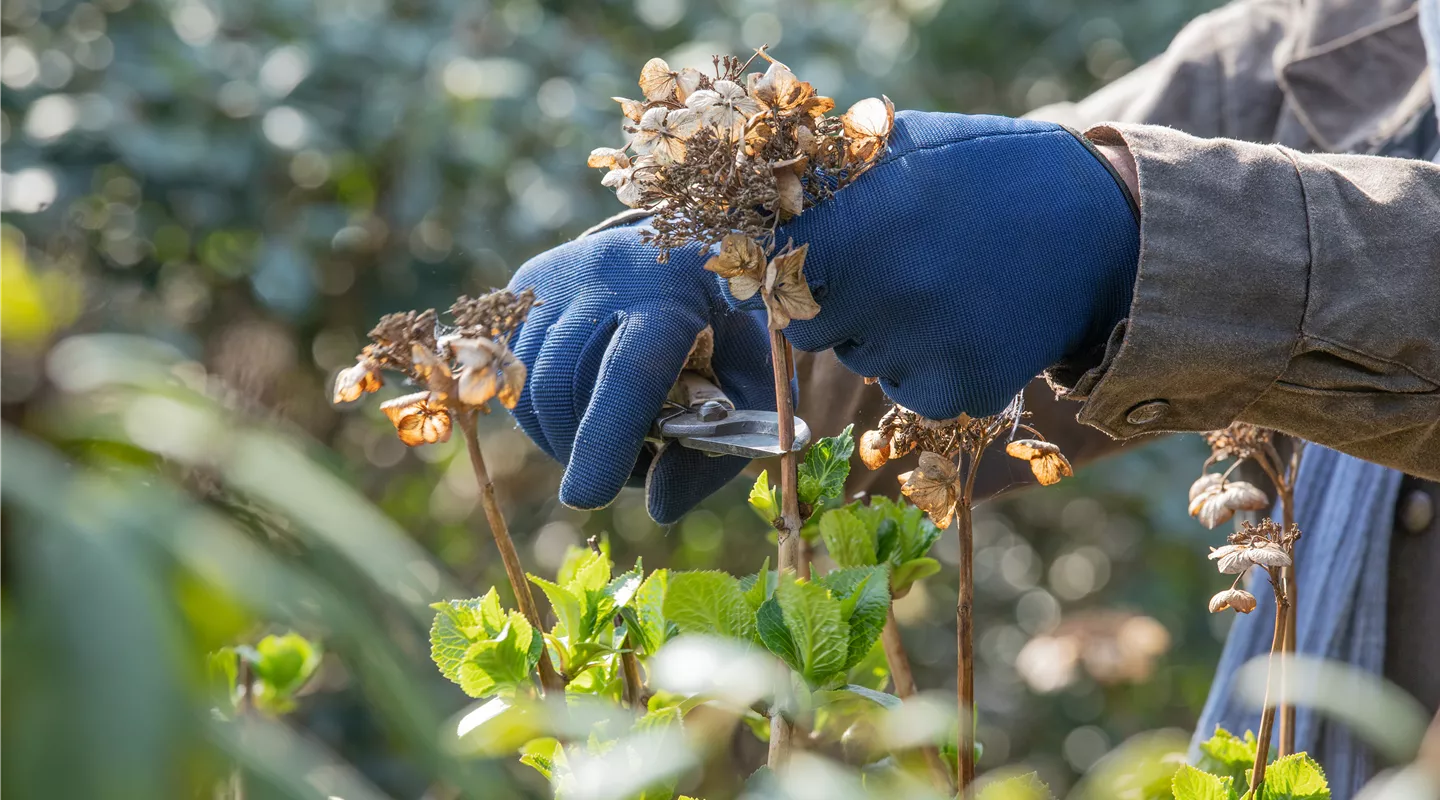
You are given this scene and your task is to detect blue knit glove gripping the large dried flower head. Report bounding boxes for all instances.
[721,112,1139,422]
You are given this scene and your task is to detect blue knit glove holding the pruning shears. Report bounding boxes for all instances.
[510,226,775,524]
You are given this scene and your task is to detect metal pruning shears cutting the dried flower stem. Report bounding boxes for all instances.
[648,370,811,459]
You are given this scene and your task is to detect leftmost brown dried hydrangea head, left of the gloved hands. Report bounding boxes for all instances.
[334,289,536,447]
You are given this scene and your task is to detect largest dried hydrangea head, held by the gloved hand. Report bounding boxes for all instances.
[589,49,894,331]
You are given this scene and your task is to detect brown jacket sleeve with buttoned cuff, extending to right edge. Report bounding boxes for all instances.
[1060,124,1440,479]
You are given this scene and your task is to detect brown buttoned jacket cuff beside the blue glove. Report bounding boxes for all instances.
[1047,124,1310,437]
